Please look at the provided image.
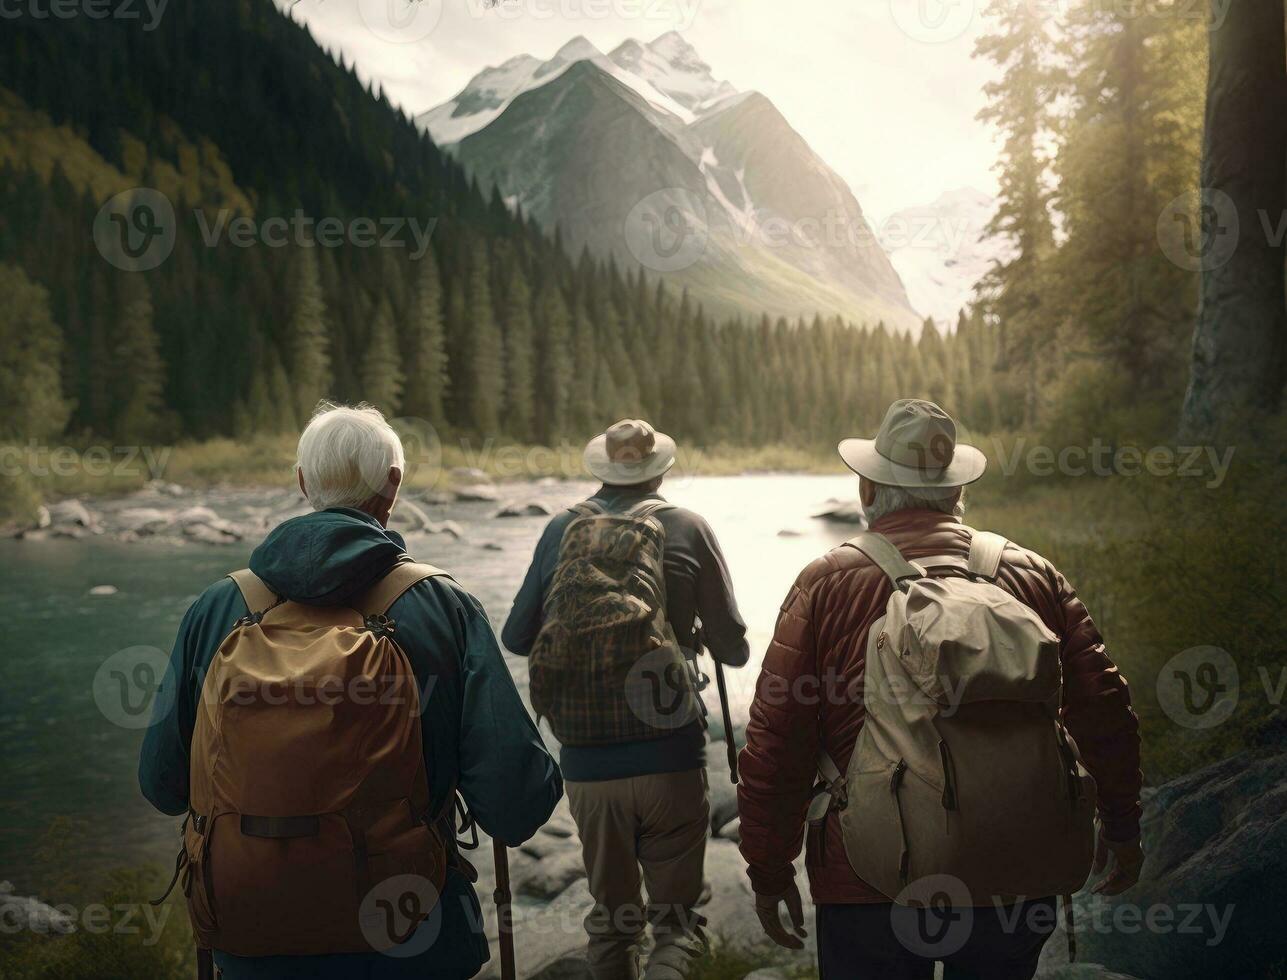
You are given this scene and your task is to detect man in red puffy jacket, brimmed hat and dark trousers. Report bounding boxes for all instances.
[737,399,1143,980]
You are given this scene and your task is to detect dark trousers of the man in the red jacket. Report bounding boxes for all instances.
[817,899,1058,980]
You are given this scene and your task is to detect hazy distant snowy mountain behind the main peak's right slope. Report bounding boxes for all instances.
[880,187,1009,327]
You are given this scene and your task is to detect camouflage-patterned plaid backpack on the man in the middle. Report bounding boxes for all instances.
[528,501,701,746]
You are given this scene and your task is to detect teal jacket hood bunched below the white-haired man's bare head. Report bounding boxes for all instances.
[250,507,407,605]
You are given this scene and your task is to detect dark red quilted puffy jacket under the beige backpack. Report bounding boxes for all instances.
[737,510,1142,904]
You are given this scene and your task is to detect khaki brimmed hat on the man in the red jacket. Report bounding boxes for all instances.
[837,398,987,489]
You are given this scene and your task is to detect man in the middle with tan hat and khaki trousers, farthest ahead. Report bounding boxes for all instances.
[502,419,749,980]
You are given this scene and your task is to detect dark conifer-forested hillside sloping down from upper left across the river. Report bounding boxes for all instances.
[0,0,1004,443]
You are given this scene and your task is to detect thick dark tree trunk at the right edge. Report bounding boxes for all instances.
[1181,0,1287,438]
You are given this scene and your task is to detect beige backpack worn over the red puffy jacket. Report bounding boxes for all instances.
[810,532,1095,905]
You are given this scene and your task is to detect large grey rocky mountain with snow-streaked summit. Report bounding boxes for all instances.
[417,31,921,332]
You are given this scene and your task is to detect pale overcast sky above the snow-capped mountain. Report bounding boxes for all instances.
[287,0,996,220]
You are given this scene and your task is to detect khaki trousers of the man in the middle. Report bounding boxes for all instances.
[565,769,710,980]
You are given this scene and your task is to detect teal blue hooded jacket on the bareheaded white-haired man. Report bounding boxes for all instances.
[139,509,562,980]
